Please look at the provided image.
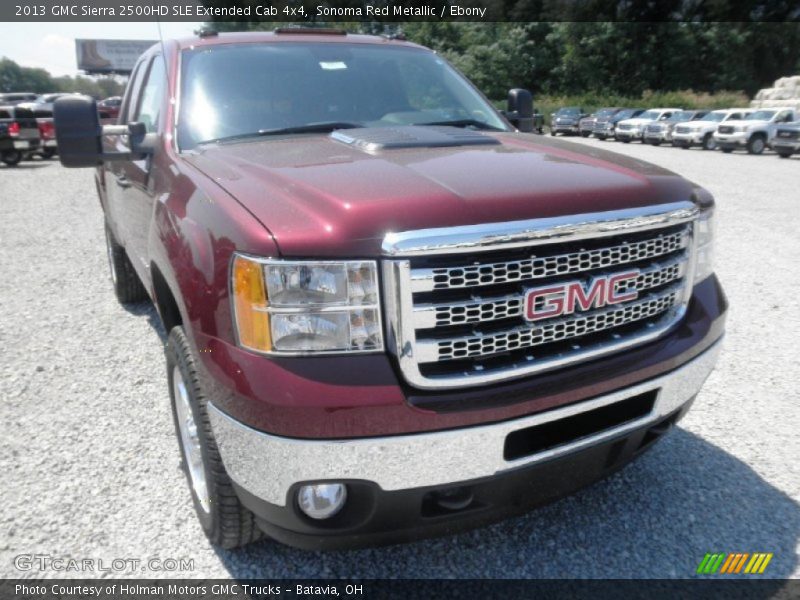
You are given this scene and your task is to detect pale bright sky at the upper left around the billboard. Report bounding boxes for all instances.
[0,22,201,76]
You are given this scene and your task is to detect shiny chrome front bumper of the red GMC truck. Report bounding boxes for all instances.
[208,342,721,506]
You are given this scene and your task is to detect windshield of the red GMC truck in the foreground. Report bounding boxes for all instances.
[177,42,508,149]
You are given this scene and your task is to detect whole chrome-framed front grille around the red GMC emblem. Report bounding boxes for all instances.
[384,202,699,389]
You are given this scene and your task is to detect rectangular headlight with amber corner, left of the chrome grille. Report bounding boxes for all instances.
[231,255,383,354]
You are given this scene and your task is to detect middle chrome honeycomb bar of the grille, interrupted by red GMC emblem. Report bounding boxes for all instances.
[412,253,688,329]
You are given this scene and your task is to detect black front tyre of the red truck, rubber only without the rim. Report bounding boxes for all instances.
[166,325,264,549]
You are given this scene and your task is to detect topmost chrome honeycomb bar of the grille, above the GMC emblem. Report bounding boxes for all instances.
[411,231,690,293]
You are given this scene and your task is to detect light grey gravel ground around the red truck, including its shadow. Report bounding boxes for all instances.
[0,139,800,578]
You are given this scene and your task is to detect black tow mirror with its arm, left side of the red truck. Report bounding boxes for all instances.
[53,95,158,168]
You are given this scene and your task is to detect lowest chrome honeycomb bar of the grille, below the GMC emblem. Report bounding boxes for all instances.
[417,287,681,363]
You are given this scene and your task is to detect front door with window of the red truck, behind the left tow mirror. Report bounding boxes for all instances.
[112,54,167,285]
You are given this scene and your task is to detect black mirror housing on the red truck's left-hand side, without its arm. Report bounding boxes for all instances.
[53,95,103,168]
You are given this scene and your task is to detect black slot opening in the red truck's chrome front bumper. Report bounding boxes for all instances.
[503,390,658,461]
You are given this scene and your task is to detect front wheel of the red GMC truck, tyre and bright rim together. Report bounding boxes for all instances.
[167,325,262,548]
